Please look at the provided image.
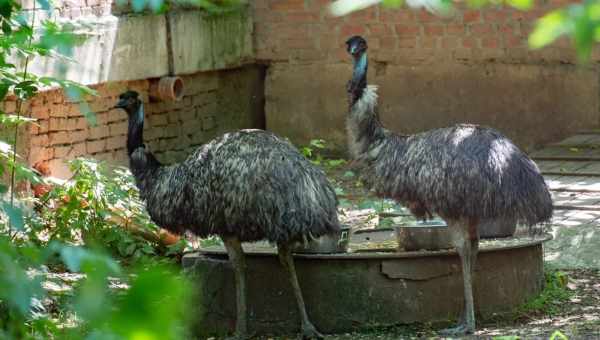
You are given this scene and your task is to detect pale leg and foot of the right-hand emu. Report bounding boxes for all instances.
[441,221,479,335]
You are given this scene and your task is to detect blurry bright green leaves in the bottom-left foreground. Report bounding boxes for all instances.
[0,235,188,339]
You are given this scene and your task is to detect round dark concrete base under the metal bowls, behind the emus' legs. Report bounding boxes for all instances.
[183,238,547,336]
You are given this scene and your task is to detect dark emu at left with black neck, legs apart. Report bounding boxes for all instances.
[115,91,340,338]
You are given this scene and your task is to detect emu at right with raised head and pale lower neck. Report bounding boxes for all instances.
[346,36,552,335]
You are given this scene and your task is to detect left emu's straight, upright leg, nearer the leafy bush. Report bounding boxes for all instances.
[223,237,249,339]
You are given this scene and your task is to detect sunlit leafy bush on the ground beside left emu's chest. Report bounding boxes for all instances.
[28,159,184,261]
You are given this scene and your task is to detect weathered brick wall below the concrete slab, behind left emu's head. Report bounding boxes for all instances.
[3,67,262,177]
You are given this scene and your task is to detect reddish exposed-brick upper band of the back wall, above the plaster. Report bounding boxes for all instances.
[252,0,588,64]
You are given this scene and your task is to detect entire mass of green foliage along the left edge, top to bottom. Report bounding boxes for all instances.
[0,0,197,339]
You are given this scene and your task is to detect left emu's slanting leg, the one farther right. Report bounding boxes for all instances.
[277,244,323,339]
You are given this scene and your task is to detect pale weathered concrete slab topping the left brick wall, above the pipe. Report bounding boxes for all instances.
[22,6,253,85]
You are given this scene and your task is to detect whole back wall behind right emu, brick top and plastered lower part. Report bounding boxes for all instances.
[252,0,600,150]
